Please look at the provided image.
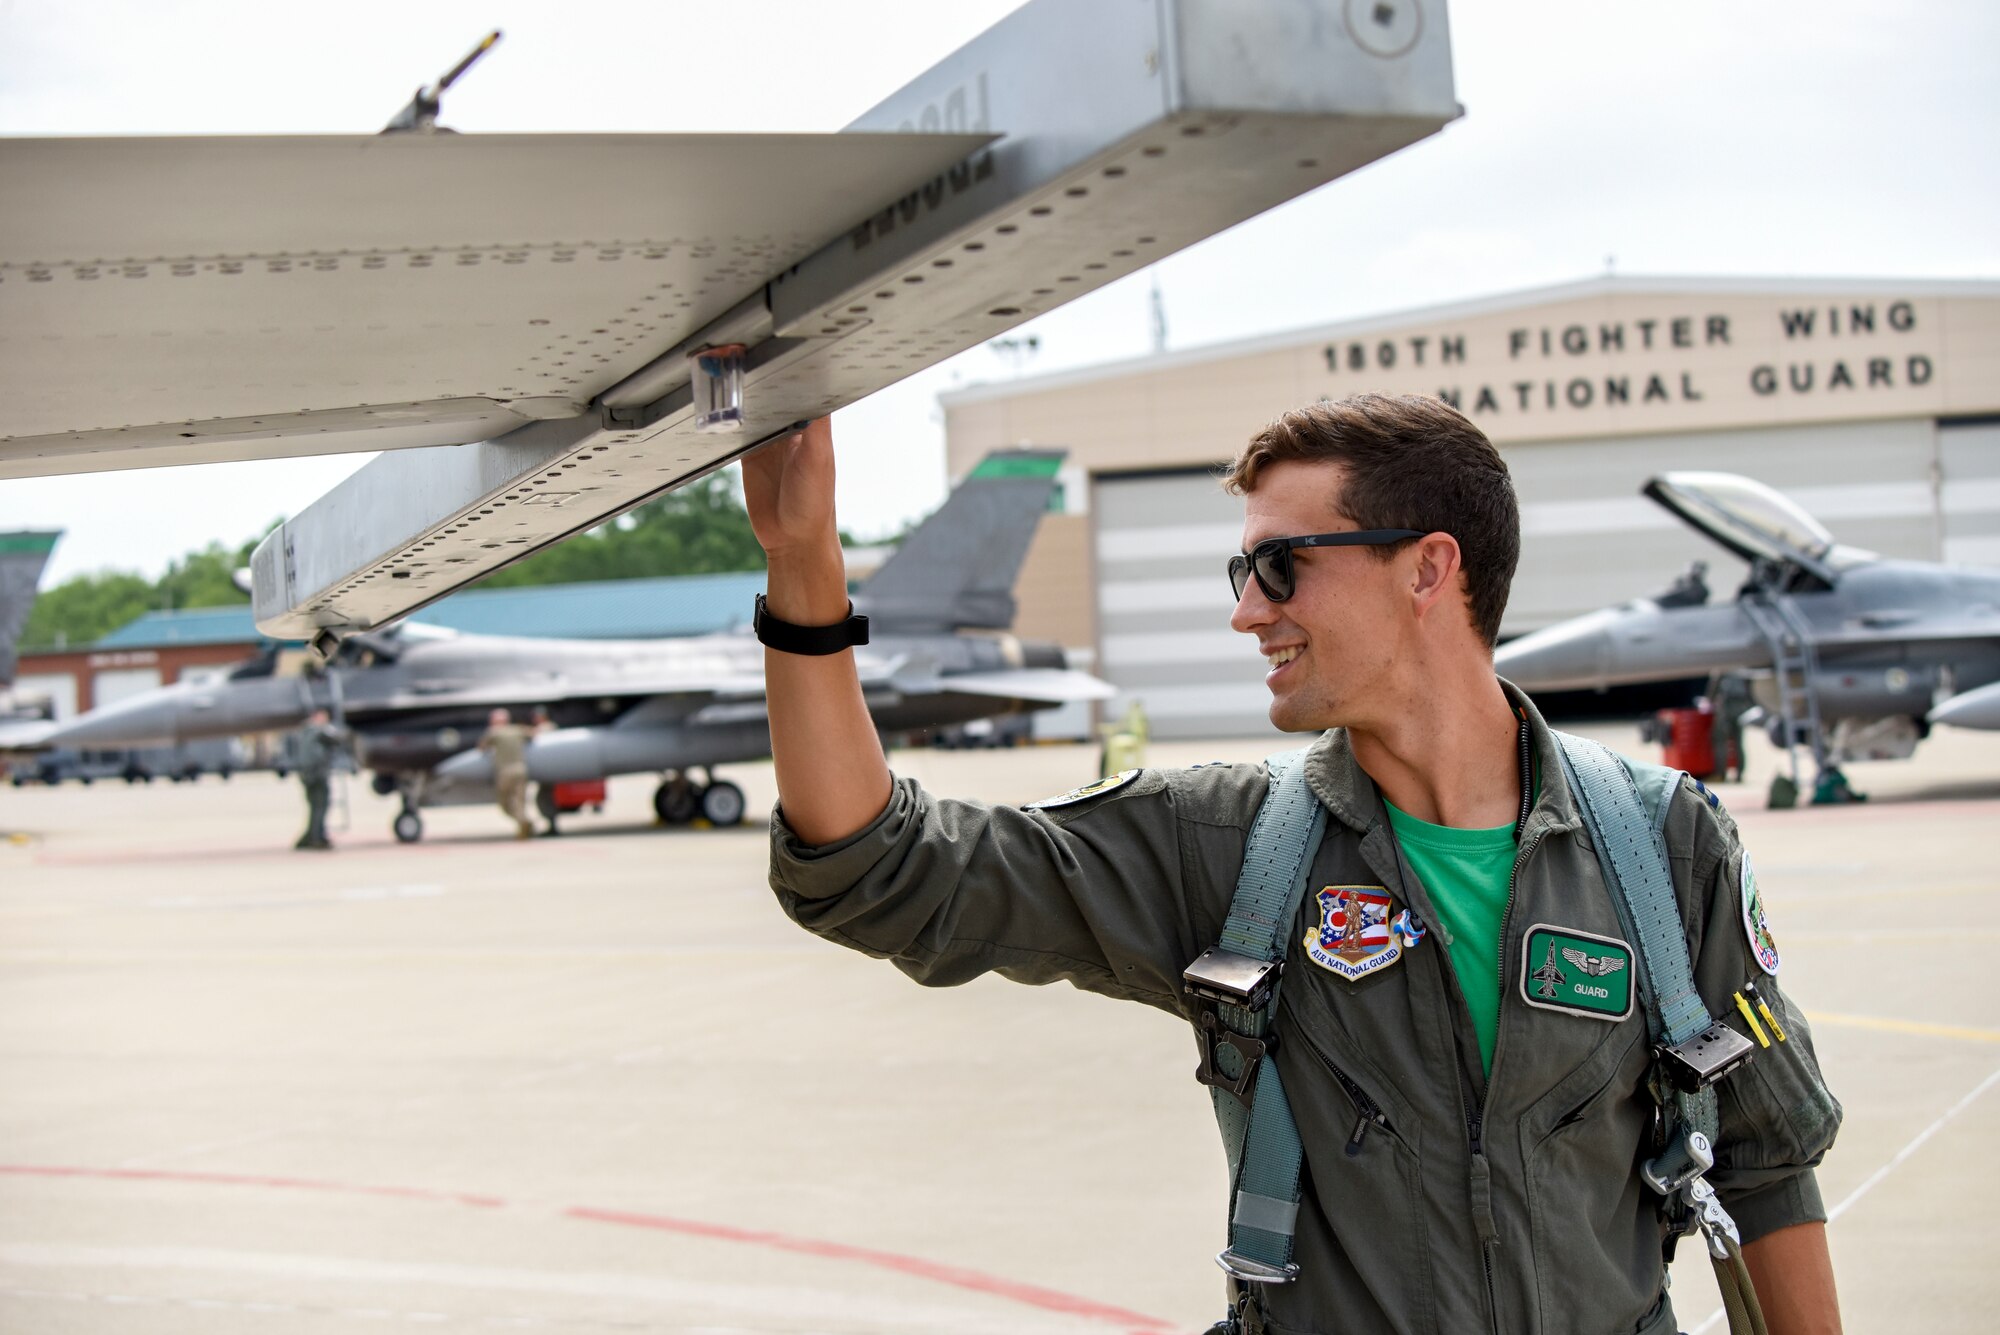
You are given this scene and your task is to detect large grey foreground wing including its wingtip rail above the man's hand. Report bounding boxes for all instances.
[145,0,1460,648]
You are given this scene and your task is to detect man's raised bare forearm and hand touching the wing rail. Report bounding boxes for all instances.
[744,418,890,845]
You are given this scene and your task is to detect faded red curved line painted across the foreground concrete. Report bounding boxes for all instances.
[0,1163,1174,1335]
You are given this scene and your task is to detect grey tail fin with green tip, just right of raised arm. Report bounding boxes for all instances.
[854,450,1066,634]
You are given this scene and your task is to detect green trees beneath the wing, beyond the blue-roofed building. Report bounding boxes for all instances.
[20,474,850,652]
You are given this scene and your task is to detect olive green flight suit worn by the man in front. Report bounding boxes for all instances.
[770,693,1840,1335]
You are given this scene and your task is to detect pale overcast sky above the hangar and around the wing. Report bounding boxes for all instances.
[0,0,2000,582]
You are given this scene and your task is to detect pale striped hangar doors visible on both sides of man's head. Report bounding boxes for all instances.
[1092,418,1944,737]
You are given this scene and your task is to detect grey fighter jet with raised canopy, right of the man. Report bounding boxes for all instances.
[1494,472,2000,805]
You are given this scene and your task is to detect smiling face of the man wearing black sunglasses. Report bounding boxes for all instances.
[1230,460,1410,731]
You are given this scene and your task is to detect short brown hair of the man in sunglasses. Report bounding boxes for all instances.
[1222,394,1520,648]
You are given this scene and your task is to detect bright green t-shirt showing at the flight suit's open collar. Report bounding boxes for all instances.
[1382,801,1514,1075]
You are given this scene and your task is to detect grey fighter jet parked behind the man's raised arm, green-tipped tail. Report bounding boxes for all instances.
[23,450,1112,841]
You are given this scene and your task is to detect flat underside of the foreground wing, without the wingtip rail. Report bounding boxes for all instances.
[0,134,990,478]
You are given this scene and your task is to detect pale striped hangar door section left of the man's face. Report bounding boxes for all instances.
[1092,470,1280,737]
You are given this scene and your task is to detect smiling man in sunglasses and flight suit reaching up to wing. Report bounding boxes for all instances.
[744,396,1840,1335]
